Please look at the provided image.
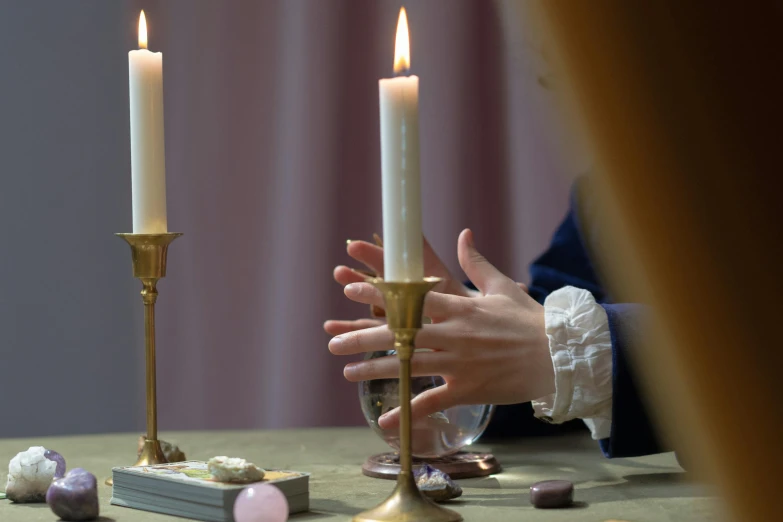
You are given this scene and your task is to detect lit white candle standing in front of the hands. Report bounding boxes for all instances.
[378,8,424,281]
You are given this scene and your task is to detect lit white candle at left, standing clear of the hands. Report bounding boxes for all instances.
[128,11,168,234]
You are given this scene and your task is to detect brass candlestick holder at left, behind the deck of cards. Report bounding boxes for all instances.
[106,232,182,486]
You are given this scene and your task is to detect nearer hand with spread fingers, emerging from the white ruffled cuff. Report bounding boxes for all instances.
[327,230,555,429]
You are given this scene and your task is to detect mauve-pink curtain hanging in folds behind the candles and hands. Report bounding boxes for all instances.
[128,0,572,429]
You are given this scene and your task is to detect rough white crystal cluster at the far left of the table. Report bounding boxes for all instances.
[5,446,57,502]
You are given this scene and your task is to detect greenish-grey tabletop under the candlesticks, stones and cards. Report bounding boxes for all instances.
[0,428,723,522]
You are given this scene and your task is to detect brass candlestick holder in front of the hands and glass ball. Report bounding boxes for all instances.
[353,277,462,522]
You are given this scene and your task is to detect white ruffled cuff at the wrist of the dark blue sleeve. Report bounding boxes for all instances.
[533,286,612,440]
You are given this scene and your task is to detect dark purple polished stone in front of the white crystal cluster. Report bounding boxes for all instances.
[46,468,100,521]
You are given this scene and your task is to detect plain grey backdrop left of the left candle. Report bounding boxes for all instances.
[0,0,144,437]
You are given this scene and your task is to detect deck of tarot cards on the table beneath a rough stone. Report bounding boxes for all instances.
[111,460,310,522]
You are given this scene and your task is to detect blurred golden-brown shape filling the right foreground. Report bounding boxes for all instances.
[537,0,783,522]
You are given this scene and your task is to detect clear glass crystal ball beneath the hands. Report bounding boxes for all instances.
[359,350,495,458]
